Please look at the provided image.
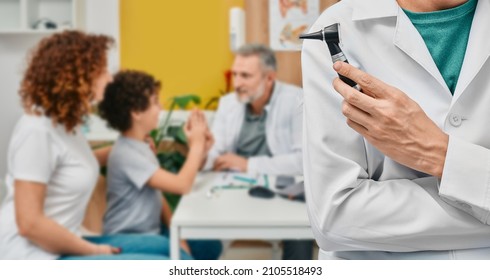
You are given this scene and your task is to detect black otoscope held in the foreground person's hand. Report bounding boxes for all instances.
[299,23,361,90]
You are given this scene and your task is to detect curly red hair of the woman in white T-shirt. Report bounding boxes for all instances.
[19,31,114,131]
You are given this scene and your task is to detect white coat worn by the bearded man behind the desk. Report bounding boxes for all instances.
[204,81,303,175]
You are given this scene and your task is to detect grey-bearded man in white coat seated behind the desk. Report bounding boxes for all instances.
[204,44,303,175]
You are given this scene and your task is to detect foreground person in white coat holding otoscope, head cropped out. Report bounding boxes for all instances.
[302,0,490,259]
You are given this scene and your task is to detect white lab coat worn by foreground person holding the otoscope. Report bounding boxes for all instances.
[302,0,490,258]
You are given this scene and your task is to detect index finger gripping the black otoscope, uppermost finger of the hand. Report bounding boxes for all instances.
[333,61,391,98]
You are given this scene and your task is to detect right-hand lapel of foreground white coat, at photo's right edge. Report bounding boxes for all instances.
[452,1,490,104]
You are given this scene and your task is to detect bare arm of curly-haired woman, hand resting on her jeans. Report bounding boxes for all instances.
[15,180,118,255]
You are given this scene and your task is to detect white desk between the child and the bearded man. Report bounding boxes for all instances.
[170,173,313,259]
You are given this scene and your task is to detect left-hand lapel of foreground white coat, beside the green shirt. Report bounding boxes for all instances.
[393,9,451,95]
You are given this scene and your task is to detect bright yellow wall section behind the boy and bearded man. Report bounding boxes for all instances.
[120,0,244,107]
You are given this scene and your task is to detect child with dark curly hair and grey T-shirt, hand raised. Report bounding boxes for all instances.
[99,70,222,259]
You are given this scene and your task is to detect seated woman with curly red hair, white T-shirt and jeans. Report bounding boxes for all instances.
[0,31,174,259]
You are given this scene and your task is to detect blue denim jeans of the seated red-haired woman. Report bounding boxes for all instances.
[59,234,192,260]
